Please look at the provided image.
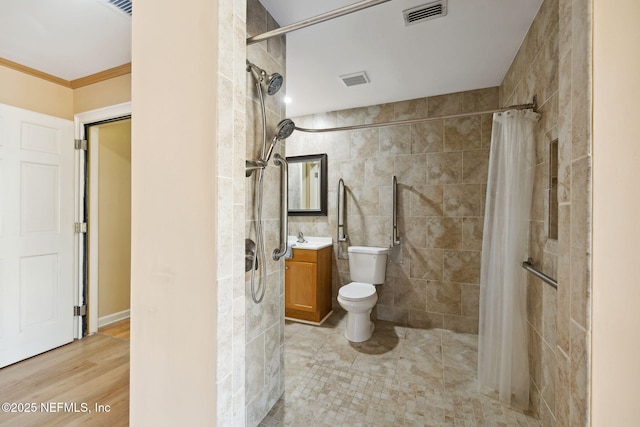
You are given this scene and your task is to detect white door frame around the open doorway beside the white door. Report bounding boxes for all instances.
[74,102,131,339]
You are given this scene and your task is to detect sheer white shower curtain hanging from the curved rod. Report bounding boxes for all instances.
[478,110,540,409]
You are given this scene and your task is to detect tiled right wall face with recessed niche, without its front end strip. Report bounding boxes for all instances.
[500,0,558,425]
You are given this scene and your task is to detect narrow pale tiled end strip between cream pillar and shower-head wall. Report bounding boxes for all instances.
[212,0,246,426]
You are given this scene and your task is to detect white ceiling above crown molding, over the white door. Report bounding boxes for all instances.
[0,0,131,81]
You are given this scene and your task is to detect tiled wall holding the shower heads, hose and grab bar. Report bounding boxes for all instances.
[244,0,286,426]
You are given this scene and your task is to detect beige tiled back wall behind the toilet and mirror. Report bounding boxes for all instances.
[286,87,498,333]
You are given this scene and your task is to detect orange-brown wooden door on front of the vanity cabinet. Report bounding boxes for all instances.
[284,261,318,312]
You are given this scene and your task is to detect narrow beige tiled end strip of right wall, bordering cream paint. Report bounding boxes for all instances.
[556,0,593,426]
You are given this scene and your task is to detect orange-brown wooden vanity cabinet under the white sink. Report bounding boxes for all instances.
[284,246,333,323]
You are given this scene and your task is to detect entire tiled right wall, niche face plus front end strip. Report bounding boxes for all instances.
[500,0,592,426]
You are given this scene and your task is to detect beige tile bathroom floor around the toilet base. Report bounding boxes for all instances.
[260,311,540,427]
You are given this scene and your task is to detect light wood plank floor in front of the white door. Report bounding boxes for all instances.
[0,319,129,426]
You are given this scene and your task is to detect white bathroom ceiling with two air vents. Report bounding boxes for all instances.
[260,0,542,117]
